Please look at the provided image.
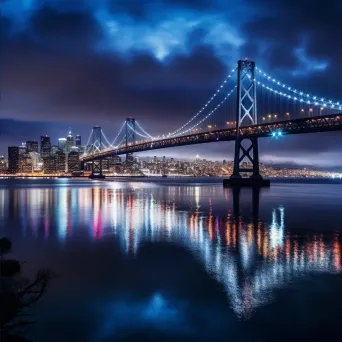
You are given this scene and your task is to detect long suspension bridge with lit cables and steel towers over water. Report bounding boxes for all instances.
[81,60,342,186]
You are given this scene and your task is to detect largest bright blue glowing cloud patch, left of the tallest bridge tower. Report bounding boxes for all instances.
[95,8,244,61]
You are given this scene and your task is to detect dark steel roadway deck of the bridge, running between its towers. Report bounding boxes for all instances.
[81,114,342,161]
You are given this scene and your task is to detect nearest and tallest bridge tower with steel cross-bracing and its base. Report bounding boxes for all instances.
[224,60,269,186]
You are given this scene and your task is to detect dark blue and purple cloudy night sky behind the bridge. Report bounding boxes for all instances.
[0,0,342,167]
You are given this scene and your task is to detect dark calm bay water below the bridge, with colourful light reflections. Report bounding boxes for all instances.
[0,180,342,342]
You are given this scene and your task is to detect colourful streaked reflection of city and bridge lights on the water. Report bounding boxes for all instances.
[0,183,342,319]
